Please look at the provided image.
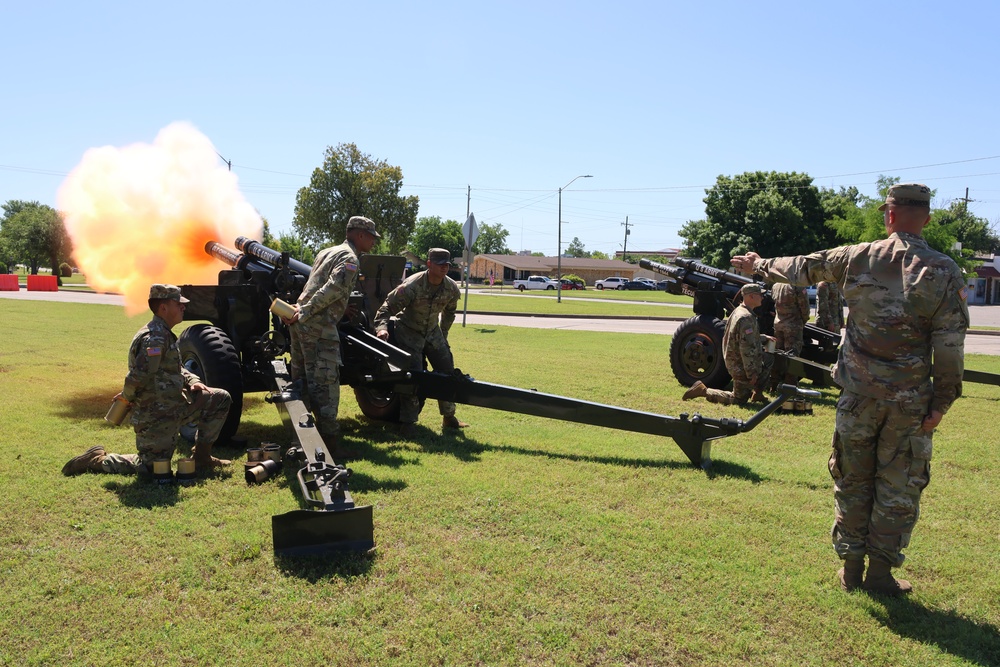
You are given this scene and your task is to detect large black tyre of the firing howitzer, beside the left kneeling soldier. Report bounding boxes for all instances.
[177,324,243,444]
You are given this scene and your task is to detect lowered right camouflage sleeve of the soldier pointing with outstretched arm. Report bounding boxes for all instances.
[931,267,969,414]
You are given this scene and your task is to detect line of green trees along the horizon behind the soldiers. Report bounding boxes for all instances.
[0,150,1000,275]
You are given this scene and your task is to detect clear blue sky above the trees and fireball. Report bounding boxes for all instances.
[0,0,1000,255]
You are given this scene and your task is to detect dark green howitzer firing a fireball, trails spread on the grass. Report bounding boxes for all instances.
[180,237,824,554]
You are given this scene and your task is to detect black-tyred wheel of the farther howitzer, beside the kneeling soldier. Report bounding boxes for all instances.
[670,315,730,389]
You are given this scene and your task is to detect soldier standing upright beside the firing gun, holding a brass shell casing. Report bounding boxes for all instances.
[282,215,381,458]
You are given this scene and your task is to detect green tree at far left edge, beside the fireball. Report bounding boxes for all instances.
[0,200,72,285]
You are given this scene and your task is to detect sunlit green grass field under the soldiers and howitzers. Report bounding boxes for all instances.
[0,297,1000,667]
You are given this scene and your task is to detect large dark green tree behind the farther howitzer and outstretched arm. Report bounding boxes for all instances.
[678,171,832,267]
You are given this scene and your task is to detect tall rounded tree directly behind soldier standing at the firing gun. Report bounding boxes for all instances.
[292,144,419,254]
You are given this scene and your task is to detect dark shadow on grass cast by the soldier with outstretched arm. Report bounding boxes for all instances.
[869,597,1000,667]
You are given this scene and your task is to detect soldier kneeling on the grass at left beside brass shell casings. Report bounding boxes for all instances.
[63,284,232,475]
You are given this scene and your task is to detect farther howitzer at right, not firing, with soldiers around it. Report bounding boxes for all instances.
[639,257,1000,389]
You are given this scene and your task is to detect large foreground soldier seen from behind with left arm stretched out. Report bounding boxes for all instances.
[732,183,969,595]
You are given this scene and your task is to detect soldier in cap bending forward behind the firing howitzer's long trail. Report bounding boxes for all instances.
[375,248,468,435]
